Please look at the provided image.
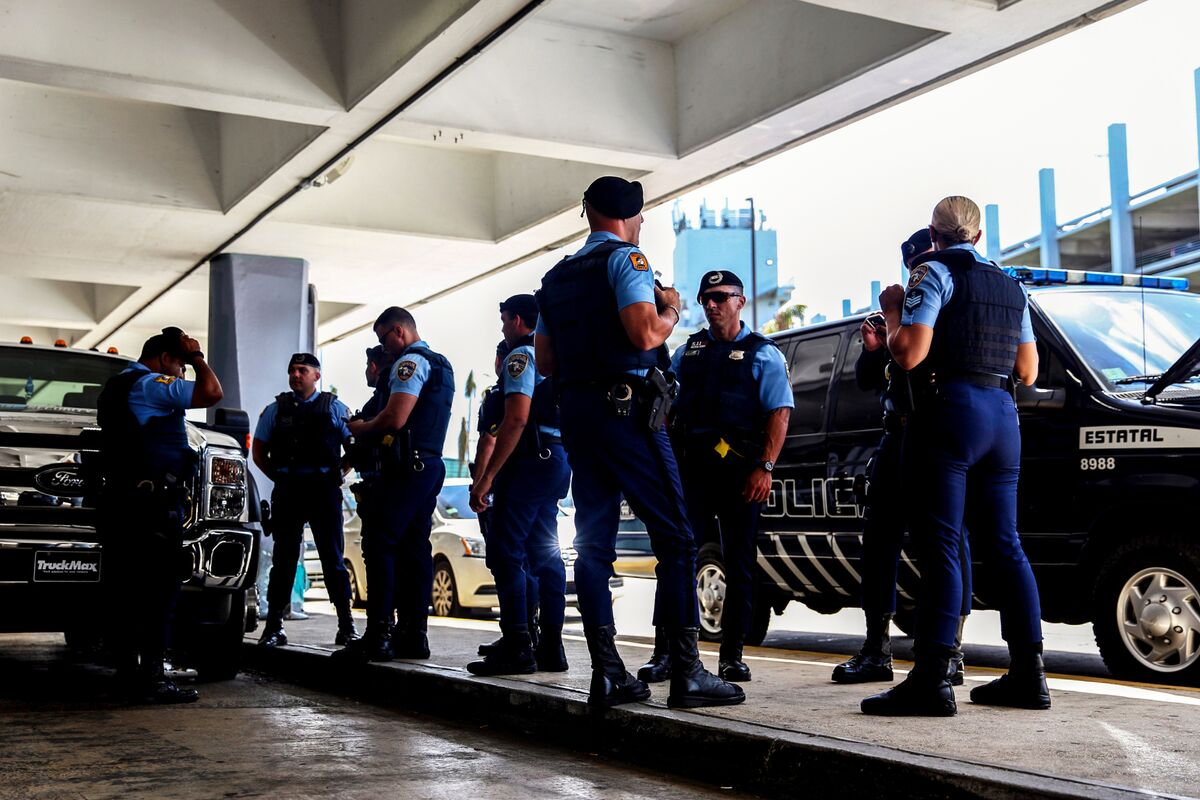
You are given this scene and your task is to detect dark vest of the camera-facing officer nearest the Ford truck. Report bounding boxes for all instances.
[269,392,342,474]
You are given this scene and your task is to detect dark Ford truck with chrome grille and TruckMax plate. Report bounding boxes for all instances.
[0,344,258,679]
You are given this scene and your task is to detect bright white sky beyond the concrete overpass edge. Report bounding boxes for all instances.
[322,0,1200,457]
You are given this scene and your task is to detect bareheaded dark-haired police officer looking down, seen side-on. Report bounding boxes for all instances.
[340,306,455,661]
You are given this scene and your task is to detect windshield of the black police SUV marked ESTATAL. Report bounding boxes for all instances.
[1036,289,1200,390]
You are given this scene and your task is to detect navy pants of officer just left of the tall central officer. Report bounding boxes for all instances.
[487,445,571,632]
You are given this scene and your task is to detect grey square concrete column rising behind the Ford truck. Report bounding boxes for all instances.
[209,253,317,497]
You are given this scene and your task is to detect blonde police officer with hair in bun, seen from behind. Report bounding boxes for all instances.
[862,197,1050,716]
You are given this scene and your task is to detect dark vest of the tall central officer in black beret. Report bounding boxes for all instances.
[536,240,668,384]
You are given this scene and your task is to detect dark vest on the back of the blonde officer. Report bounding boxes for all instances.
[926,249,1026,375]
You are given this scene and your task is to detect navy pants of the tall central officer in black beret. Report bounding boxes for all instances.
[559,387,700,627]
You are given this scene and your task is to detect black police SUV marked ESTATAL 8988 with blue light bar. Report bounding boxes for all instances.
[698,267,1200,685]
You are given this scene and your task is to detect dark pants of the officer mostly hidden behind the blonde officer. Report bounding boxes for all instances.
[863,426,971,616]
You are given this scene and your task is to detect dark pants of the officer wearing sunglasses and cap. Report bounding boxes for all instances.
[680,452,762,645]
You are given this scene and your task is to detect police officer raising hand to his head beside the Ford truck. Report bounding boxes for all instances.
[97,327,224,703]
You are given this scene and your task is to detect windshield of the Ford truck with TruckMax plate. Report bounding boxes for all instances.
[0,345,130,411]
